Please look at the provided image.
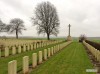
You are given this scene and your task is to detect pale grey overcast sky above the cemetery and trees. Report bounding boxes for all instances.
[0,0,100,37]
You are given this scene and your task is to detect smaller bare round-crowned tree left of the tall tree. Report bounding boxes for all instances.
[8,18,26,39]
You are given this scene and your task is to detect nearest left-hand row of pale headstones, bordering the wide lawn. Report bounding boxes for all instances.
[8,41,71,74]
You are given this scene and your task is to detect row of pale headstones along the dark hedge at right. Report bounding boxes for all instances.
[83,41,100,62]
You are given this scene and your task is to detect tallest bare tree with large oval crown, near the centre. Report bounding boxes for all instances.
[32,2,60,40]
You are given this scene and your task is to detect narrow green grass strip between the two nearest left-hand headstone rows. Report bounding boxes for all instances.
[0,42,63,74]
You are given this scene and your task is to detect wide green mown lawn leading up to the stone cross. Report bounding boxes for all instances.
[30,42,96,74]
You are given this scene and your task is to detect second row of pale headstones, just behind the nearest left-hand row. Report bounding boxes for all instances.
[0,41,62,57]
